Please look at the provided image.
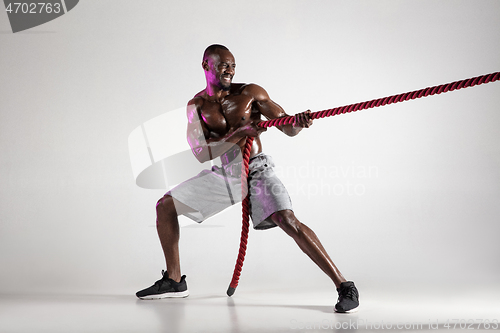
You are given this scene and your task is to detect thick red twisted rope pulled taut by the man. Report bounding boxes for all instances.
[227,72,500,296]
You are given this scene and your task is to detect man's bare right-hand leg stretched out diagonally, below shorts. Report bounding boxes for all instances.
[271,210,346,288]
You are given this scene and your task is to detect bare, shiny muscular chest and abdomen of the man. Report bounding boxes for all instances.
[196,84,262,156]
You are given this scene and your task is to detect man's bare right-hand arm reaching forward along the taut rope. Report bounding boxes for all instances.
[244,84,313,136]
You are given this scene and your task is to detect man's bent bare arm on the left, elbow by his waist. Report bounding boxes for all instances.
[187,98,265,163]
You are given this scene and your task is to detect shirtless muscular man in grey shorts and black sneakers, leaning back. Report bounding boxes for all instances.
[136,44,359,312]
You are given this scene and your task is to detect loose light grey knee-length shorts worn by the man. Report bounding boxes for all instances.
[167,153,292,229]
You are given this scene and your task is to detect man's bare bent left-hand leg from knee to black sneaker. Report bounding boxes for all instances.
[156,195,195,282]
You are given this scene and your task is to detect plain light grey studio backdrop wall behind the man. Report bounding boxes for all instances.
[0,0,500,294]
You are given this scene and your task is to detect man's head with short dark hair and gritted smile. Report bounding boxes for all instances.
[201,44,236,90]
